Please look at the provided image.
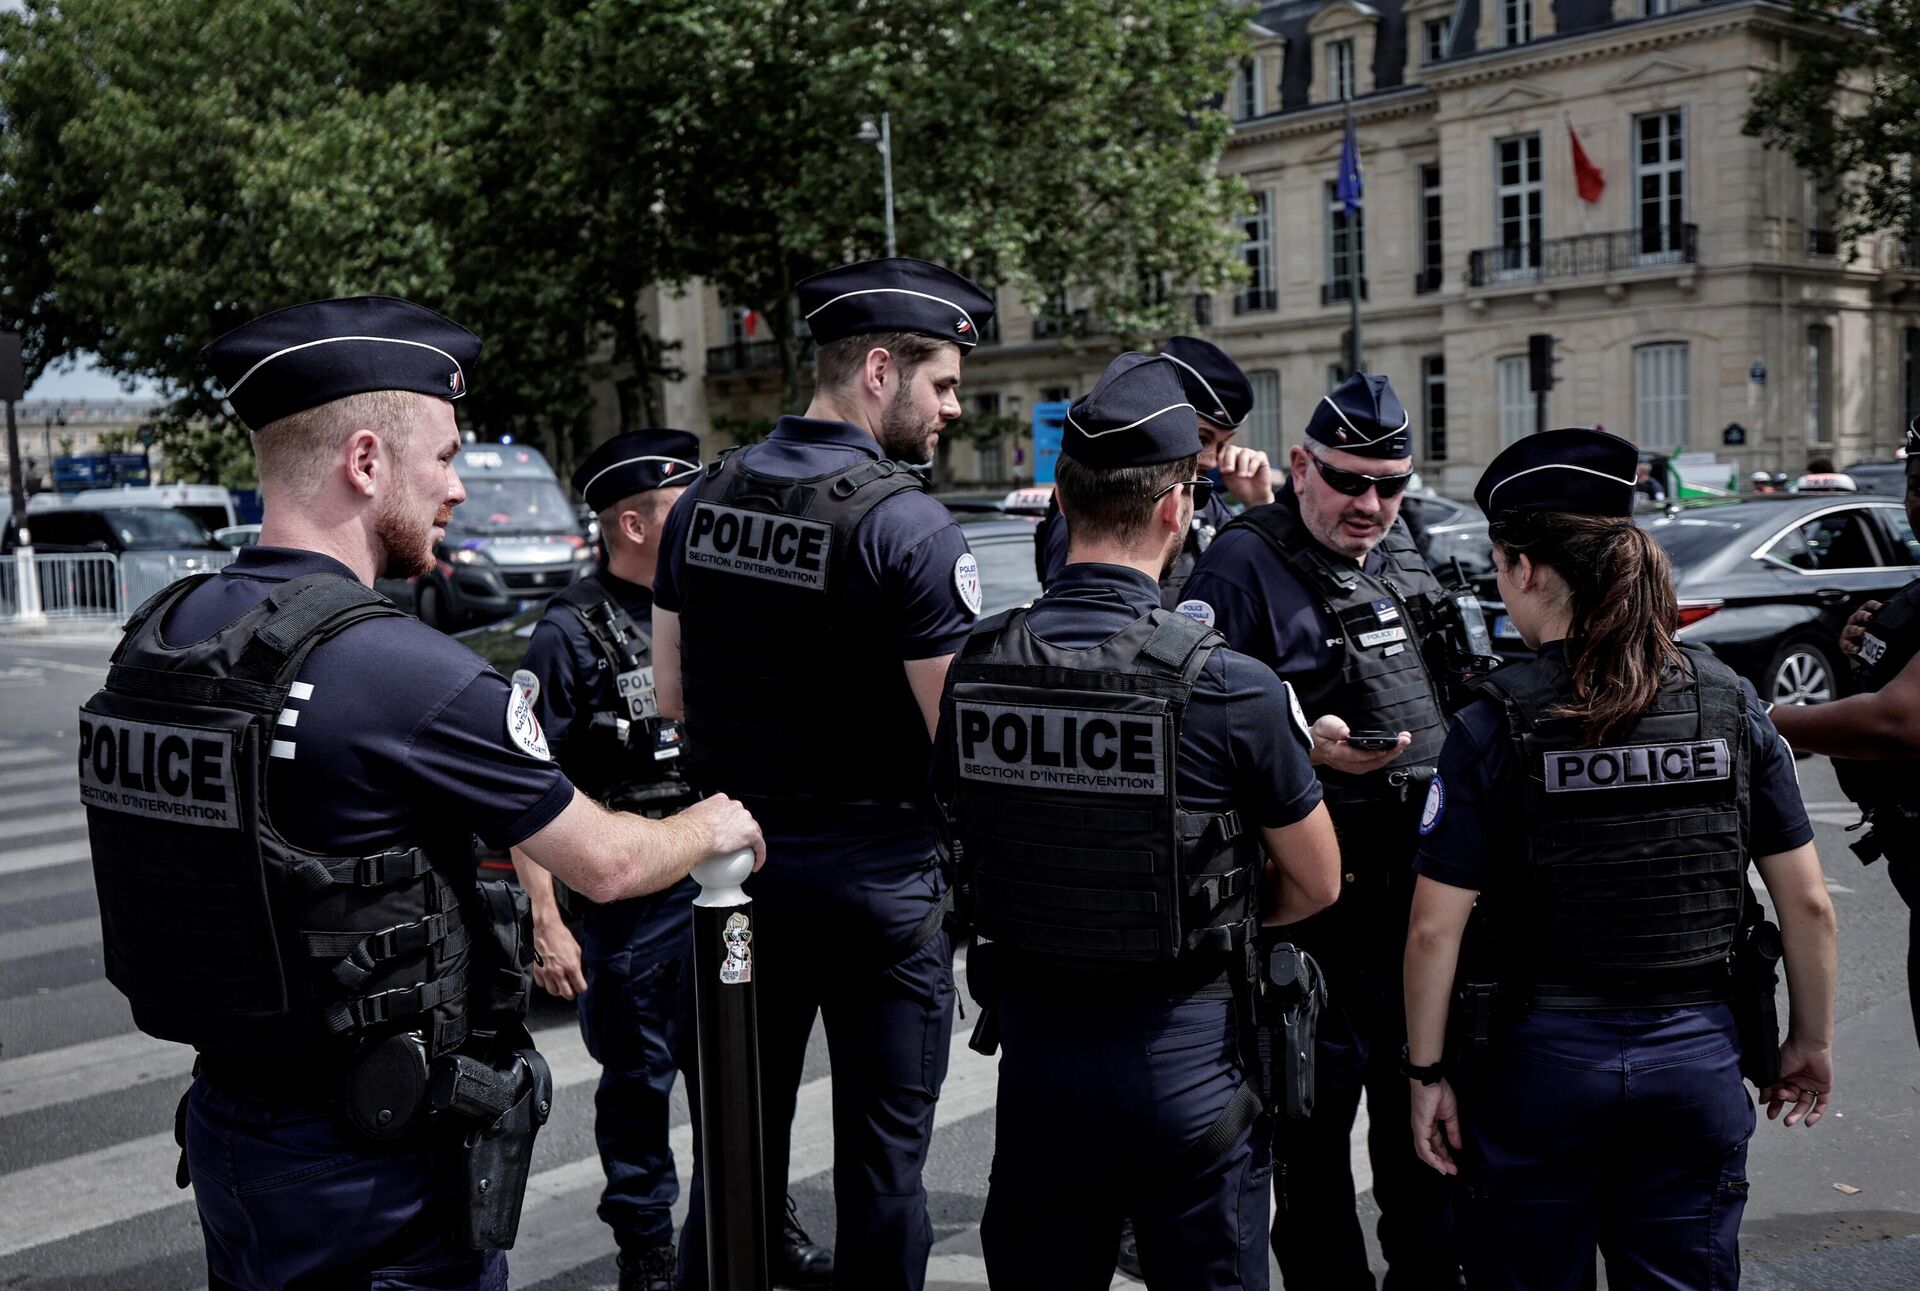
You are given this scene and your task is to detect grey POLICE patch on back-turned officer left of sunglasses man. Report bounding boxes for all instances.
[954,703,1167,795]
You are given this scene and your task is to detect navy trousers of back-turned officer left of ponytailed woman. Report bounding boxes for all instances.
[979,991,1269,1291]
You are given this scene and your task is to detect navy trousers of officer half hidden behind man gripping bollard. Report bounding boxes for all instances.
[580,878,699,1245]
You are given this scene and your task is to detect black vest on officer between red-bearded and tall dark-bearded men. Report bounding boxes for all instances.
[553,572,693,816]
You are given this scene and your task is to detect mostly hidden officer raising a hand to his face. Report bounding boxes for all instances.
[1033,336,1273,607]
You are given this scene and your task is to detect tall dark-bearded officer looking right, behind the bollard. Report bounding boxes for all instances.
[653,259,993,1287]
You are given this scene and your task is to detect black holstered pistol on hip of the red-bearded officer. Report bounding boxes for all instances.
[430,1047,553,1251]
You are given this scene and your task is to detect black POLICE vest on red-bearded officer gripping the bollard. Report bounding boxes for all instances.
[79,574,486,1064]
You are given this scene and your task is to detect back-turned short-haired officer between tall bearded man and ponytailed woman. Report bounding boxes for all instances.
[935,353,1338,1291]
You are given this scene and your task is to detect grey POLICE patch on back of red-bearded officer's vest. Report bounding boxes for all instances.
[81,711,240,830]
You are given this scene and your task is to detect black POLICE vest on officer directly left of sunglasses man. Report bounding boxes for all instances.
[950,609,1261,972]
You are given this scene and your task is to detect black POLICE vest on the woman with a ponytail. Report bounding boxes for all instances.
[1480,646,1751,1007]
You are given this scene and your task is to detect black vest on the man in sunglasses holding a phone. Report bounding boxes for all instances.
[1227,498,1446,803]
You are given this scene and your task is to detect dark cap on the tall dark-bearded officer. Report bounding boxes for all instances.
[795,256,993,350]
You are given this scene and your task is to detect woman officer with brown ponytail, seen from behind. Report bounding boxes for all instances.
[1405,430,1834,1289]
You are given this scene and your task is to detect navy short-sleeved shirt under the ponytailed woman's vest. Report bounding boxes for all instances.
[1413,642,1812,891]
